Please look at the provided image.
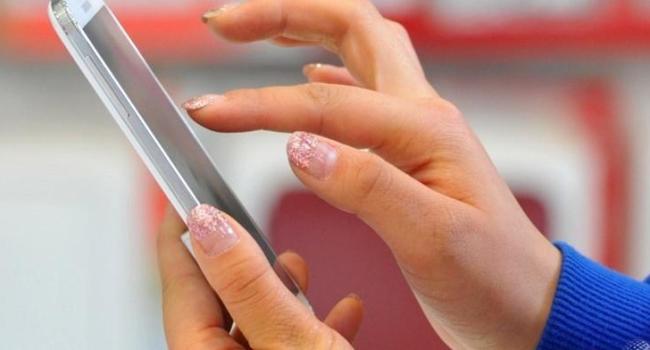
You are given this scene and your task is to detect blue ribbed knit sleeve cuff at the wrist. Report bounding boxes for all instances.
[538,243,650,350]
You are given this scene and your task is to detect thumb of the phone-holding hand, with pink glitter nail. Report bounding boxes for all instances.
[188,205,344,348]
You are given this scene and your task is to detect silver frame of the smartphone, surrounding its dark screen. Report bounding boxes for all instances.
[48,0,310,307]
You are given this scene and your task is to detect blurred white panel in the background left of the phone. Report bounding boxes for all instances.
[0,135,162,349]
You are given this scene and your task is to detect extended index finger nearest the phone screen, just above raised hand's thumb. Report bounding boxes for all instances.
[184,84,430,168]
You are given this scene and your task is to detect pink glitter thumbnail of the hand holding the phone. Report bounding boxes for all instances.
[187,204,239,257]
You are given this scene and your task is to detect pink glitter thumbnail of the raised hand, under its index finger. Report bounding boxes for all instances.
[287,132,338,180]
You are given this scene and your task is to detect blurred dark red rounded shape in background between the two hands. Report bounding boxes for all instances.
[270,192,547,350]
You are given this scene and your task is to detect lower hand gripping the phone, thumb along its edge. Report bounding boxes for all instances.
[158,206,363,350]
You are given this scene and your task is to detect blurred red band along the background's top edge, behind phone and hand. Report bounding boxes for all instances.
[6,0,650,62]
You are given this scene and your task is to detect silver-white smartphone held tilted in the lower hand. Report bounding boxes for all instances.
[48,0,309,306]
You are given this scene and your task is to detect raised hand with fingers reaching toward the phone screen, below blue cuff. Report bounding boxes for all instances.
[185,0,561,349]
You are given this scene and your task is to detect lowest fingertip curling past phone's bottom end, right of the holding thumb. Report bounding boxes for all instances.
[325,294,363,343]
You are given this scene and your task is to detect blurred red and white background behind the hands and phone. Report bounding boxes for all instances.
[0,0,650,349]
